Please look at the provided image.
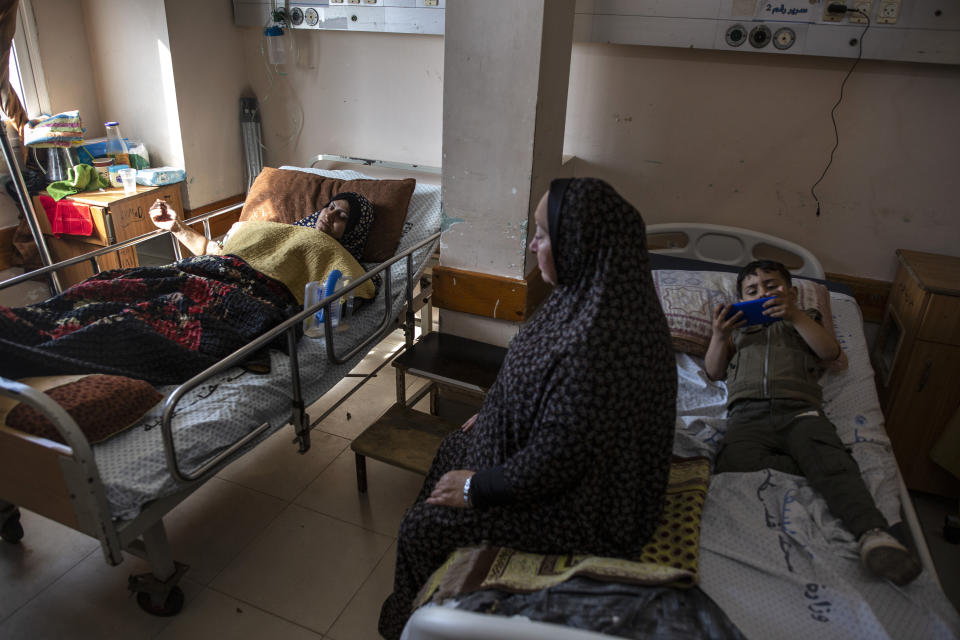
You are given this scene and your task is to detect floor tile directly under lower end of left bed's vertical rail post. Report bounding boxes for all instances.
[217,426,350,502]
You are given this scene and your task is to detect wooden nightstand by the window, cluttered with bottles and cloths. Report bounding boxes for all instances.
[33,183,183,289]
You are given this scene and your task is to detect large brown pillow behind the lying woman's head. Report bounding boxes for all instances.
[240,167,417,262]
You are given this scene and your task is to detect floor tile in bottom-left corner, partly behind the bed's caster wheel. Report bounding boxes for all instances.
[0,553,202,640]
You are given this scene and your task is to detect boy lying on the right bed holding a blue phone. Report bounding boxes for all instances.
[705,260,921,585]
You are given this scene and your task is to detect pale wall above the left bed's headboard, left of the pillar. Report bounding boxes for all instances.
[234,29,443,171]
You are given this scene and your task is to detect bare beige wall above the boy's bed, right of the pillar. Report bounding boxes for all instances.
[564,44,960,281]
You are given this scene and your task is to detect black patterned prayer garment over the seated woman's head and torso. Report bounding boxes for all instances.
[463,178,677,556]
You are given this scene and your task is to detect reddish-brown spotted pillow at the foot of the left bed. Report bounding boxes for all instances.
[5,374,163,444]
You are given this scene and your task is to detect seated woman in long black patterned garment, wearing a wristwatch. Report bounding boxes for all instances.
[380,179,677,638]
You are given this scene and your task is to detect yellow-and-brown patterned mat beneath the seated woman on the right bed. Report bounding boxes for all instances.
[415,458,710,606]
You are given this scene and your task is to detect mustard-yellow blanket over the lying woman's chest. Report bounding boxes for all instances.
[223,220,375,304]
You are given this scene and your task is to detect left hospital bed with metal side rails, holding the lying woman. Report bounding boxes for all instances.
[0,156,442,615]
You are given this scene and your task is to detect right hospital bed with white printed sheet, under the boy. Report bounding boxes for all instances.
[404,224,960,640]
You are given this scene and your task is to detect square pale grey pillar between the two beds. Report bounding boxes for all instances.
[440,0,574,342]
